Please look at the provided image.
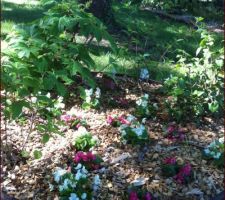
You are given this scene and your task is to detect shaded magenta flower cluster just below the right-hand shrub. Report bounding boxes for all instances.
[165,124,185,141]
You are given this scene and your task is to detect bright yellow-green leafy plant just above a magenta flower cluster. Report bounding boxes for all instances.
[74,132,98,151]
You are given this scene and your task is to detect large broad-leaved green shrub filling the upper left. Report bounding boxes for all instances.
[2,0,116,122]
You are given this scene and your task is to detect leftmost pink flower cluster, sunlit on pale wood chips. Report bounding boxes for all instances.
[60,114,87,129]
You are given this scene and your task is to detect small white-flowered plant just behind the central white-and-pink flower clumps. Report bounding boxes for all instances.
[135,94,150,117]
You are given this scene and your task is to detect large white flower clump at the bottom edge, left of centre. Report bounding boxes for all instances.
[53,163,101,200]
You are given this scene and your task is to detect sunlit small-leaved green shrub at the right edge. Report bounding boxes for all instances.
[165,25,224,121]
